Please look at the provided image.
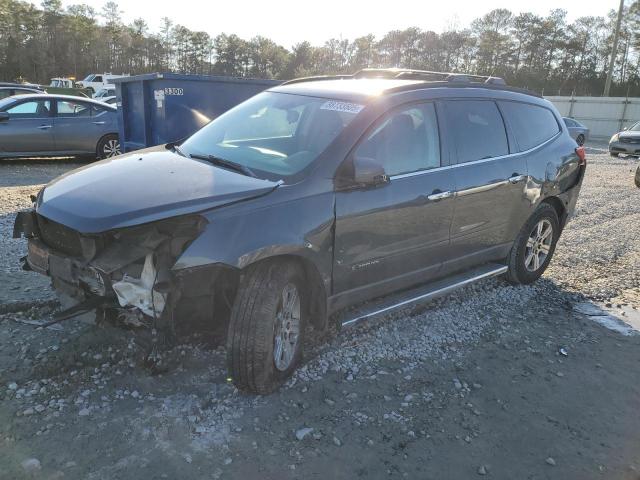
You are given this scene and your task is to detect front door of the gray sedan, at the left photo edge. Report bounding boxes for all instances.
[0,99,55,155]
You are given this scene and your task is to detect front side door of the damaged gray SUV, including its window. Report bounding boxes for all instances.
[333,103,455,298]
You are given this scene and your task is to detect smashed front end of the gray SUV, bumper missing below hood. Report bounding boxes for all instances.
[13,210,206,326]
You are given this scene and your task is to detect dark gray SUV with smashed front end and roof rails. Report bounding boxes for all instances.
[14,69,586,393]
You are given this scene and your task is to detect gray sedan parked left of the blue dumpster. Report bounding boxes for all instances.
[0,94,120,158]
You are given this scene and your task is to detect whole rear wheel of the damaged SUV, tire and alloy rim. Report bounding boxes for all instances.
[506,203,560,284]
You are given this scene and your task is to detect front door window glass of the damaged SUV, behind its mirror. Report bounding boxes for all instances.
[356,103,440,176]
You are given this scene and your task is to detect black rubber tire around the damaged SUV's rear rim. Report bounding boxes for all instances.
[506,203,560,284]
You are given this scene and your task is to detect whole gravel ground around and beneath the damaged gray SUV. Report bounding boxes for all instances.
[0,149,640,480]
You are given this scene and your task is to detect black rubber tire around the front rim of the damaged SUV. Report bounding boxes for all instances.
[227,261,308,394]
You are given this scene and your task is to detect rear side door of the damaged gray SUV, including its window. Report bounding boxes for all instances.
[443,99,530,269]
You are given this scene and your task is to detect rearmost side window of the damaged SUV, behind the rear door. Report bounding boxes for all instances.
[500,102,560,152]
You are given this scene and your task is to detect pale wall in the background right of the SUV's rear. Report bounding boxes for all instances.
[545,97,640,139]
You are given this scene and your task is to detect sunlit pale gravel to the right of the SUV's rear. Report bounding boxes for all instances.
[546,149,640,300]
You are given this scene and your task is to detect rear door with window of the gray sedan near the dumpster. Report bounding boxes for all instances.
[53,99,110,153]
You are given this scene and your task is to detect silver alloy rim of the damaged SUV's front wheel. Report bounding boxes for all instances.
[273,283,300,372]
